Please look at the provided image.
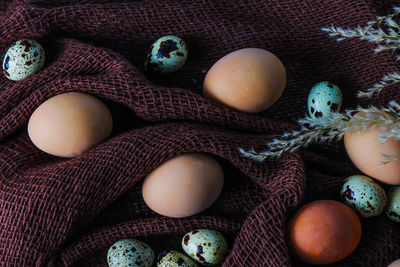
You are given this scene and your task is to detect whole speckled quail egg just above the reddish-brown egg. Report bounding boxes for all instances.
[341,175,387,218]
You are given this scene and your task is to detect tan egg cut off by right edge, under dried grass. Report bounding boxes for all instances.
[344,113,400,185]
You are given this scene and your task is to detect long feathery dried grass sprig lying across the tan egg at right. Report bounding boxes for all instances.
[238,101,400,161]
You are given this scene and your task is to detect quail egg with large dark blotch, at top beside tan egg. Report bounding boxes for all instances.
[145,35,188,74]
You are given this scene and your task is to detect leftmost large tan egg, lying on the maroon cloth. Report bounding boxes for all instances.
[28,92,112,157]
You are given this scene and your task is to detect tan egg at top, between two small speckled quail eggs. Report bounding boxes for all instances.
[203,48,286,113]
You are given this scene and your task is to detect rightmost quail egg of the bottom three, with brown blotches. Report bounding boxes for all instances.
[182,229,228,266]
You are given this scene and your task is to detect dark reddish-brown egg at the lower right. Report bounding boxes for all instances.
[289,200,361,264]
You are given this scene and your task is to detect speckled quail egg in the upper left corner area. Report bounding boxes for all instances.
[3,39,45,81]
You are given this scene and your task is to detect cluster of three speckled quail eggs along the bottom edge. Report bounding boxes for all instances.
[107,229,228,267]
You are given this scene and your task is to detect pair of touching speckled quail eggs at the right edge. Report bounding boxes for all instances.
[340,175,400,222]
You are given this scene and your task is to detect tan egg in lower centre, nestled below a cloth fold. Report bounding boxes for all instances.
[142,153,224,217]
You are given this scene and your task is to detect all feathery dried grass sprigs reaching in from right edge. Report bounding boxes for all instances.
[238,7,400,164]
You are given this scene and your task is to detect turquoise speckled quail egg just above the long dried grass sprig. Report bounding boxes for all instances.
[307,81,342,119]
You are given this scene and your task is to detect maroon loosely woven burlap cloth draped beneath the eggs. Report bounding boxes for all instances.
[0,0,400,266]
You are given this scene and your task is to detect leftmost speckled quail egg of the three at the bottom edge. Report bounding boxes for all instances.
[107,239,154,267]
